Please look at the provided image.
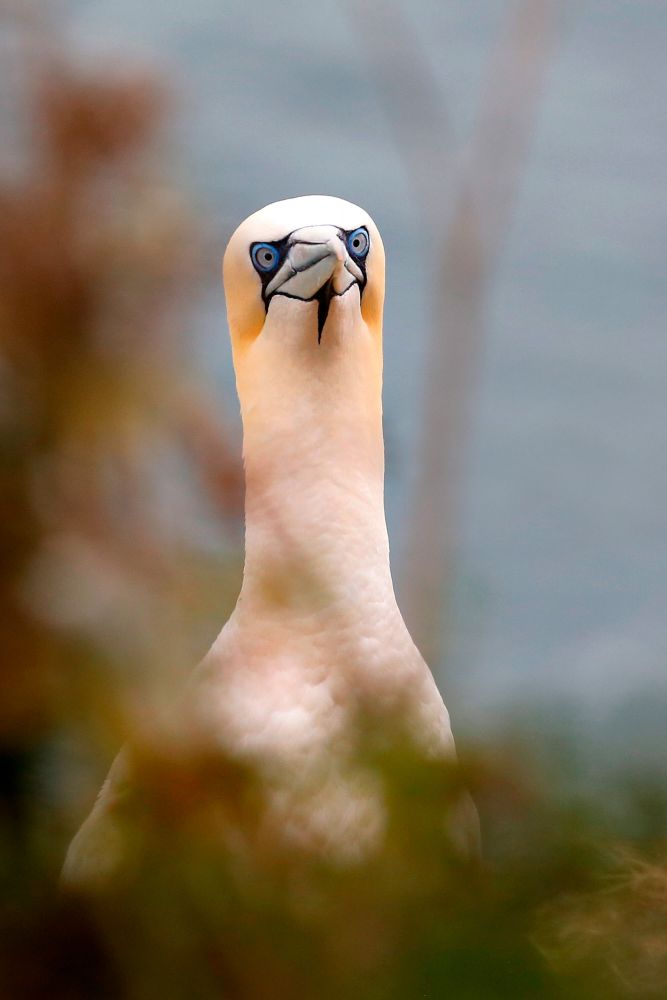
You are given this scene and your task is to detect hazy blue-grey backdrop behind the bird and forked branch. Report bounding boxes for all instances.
[61,0,667,736]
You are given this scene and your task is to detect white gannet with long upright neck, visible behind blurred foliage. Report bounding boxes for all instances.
[64,195,478,883]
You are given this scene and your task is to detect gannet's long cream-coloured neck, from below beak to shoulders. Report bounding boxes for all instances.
[237,295,394,613]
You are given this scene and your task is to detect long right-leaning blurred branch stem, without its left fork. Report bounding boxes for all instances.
[405,0,563,664]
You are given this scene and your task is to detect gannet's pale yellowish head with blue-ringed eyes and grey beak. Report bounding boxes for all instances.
[223,195,384,360]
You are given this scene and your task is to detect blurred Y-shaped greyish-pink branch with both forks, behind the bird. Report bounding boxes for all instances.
[342,0,563,664]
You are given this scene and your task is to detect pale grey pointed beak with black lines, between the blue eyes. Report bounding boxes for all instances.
[264,226,364,343]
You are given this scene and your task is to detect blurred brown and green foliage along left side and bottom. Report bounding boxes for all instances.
[0,15,667,1000]
